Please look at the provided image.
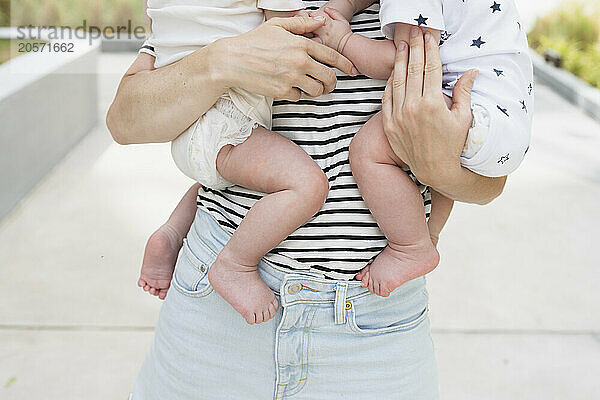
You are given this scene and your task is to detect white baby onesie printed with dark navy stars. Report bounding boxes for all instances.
[380,0,533,177]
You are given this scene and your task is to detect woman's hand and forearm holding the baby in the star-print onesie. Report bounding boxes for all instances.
[383,28,506,204]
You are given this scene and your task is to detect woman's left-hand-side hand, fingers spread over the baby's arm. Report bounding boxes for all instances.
[213,15,358,101]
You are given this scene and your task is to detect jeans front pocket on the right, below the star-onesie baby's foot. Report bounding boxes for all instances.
[348,291,429,335]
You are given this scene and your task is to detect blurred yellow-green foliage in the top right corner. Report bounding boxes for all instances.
[528,1,600,88]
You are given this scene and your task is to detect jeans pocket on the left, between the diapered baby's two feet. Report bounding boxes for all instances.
[172,239,216,297]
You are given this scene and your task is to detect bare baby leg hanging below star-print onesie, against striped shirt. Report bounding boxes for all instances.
[350,113,439,296]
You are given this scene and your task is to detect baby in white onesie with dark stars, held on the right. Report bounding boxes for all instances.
[311,0,533,296]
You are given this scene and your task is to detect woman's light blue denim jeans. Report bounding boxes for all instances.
[132,210,438,400]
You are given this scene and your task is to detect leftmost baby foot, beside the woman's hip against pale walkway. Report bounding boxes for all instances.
[138,224,182,300]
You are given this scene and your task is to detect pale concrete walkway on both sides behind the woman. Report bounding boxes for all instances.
[0,50,600,400]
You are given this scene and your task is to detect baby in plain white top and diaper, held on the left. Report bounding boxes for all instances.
[138,0,340,324]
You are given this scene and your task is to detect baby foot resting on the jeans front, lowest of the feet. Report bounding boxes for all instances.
[208,252,279,325]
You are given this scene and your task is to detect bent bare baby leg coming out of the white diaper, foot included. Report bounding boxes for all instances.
[208,127,329,324]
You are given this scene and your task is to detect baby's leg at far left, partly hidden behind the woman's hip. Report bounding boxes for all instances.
[138,183,200,300]
